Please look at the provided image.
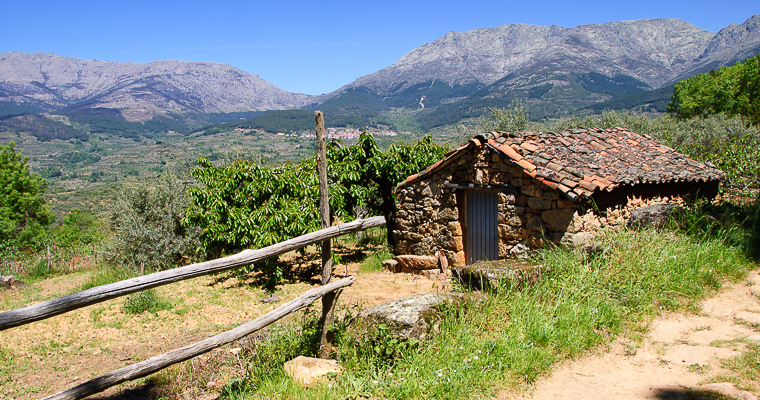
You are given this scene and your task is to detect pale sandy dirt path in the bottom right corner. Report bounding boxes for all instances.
[498,271,760,400]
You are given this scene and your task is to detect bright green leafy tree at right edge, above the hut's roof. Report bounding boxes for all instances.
[668,54,760,125]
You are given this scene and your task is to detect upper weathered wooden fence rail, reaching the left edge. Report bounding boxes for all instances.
[0,217,385,331]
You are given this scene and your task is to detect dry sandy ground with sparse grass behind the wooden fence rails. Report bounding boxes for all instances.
[0,250,449,399]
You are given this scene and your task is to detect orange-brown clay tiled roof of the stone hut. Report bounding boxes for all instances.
[399,128,724,199]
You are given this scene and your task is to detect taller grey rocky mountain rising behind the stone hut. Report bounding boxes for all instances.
[330,15,760,122]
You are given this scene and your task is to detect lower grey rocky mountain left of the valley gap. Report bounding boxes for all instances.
[0,52,314,121]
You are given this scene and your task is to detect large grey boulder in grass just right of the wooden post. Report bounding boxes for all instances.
[351,293,463,340]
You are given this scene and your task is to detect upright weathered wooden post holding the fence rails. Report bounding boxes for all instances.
[314,111,340,358]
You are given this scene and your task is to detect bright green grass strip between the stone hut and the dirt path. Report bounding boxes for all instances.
[211,205,757,399]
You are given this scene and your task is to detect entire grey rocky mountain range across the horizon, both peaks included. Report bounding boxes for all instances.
[0,15,760,133]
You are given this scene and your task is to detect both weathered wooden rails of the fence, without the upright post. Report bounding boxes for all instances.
[0,217,385,399]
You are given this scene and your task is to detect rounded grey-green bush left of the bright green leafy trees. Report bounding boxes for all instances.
[105,173,200,271]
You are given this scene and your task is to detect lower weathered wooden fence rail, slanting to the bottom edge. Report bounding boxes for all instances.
[43,276,354,400]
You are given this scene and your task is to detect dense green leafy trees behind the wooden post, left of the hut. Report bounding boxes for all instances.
[185,132,444,286]
